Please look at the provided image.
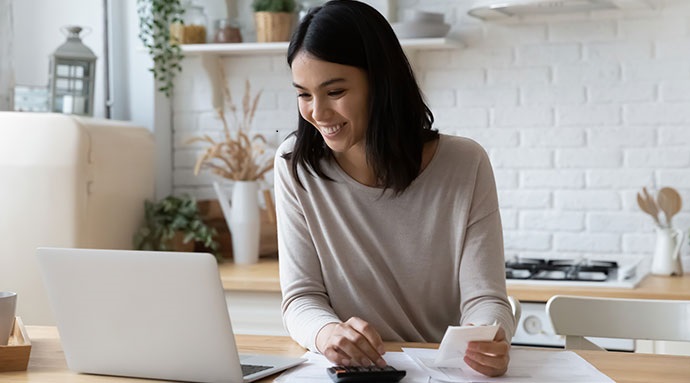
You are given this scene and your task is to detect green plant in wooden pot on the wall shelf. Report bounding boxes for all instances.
[252,0,296,42]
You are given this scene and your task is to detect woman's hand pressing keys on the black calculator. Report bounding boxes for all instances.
[316,317,386,367]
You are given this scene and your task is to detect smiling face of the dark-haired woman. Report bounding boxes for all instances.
[292,52,369,157]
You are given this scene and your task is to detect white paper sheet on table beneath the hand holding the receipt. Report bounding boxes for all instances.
[403,348,615,383]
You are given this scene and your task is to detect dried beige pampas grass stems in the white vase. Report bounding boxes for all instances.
[188,64,273,181]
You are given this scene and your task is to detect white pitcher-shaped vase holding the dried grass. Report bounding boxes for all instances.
[213,181,261,264]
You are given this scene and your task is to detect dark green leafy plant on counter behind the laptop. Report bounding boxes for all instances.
[134,194,220,260]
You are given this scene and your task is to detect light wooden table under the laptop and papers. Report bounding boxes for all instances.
[0,326,690,383]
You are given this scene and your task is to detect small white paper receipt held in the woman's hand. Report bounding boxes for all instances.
[434,324,498,367]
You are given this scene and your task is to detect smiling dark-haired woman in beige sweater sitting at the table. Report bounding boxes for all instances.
[275,0,515,376]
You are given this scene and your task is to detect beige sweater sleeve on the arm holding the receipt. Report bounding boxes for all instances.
[459,145,516,342]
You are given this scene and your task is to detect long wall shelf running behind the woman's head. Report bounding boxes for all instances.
[182,37,462,56]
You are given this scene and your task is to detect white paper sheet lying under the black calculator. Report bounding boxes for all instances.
[274,352,429,383]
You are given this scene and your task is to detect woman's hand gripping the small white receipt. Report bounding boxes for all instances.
[464,327,510,376]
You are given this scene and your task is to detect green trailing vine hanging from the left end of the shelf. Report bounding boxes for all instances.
[137,0,184,97]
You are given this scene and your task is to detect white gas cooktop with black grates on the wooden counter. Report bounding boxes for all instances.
[505,256,646,288]
